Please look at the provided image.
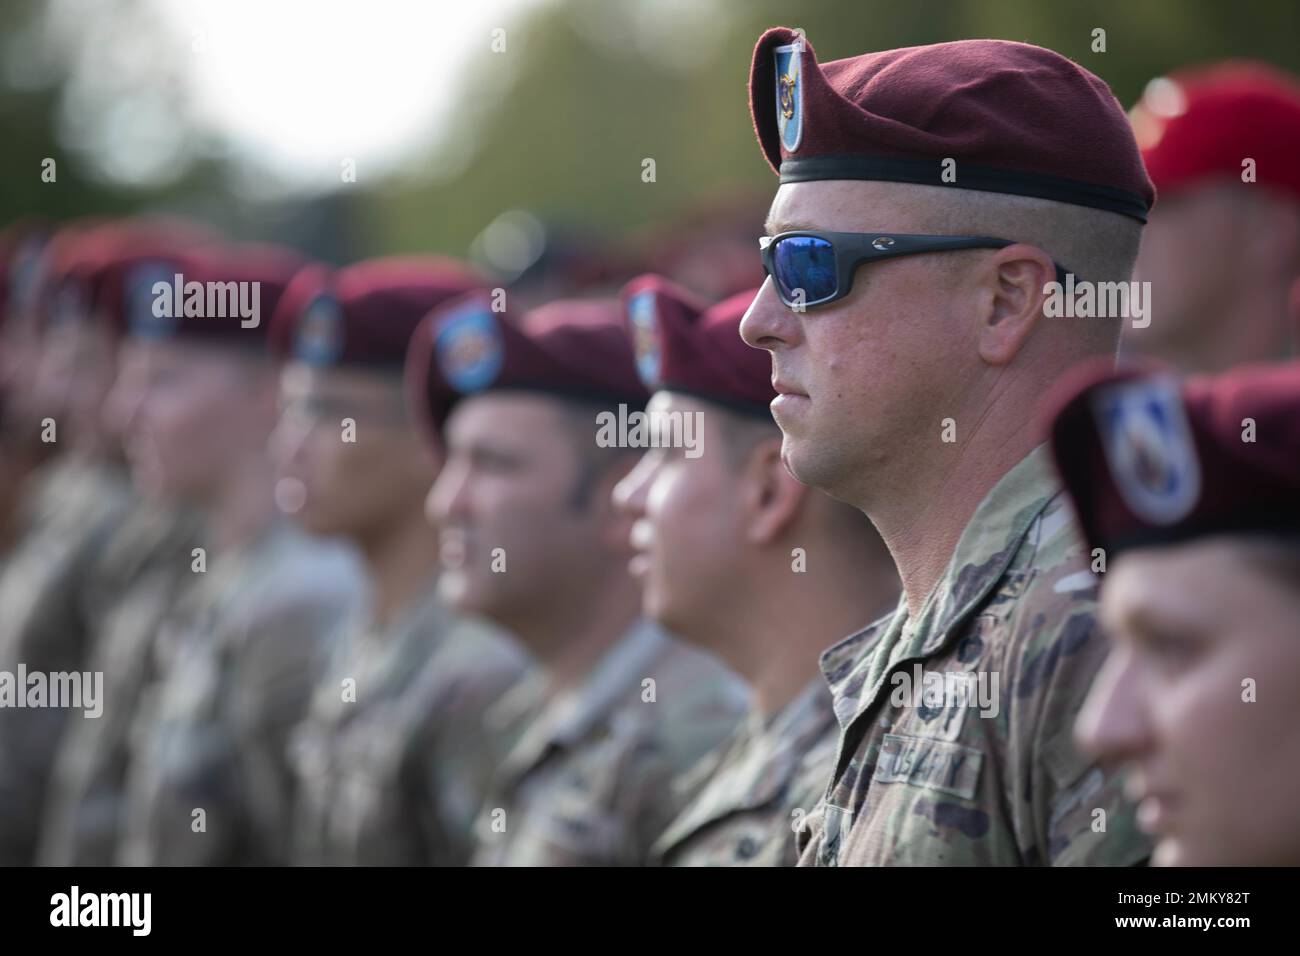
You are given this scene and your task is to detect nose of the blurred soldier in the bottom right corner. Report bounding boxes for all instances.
[1074,648,1151,766]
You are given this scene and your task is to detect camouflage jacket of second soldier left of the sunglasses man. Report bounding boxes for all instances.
[473,622,748,866]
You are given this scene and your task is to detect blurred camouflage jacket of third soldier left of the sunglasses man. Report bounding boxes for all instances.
[291,581,527,866]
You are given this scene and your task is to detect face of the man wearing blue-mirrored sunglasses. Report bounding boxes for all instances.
[741,182,976,499]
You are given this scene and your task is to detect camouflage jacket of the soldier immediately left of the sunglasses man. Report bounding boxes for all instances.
[655,676,840,866]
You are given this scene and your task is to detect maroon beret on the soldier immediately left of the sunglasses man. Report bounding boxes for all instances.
[623,276,776,420]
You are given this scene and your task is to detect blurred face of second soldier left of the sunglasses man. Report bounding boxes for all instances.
[426,392,612,628]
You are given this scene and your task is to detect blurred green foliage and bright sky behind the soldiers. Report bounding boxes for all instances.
[0,0,1300,282]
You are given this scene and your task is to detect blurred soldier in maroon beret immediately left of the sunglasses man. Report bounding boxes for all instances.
[615,276,898,866]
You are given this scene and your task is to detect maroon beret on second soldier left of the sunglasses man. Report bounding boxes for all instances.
[406,291,650,439]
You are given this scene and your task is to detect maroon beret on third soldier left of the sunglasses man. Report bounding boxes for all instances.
[270,256,485,369]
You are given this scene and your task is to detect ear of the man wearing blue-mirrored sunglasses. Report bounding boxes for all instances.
[978,243,1056,365]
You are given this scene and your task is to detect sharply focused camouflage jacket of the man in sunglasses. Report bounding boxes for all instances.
[800,446,1149,866]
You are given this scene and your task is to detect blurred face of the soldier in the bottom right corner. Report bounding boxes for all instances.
[1076,538,1300,866]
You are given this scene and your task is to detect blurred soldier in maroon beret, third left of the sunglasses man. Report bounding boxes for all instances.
[273,258,525,865]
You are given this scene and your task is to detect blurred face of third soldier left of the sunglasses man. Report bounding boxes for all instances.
[270,362,434,541]
